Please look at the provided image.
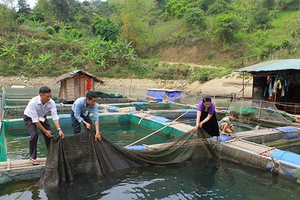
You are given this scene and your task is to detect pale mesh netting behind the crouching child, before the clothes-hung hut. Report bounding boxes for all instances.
[228,99,293,126]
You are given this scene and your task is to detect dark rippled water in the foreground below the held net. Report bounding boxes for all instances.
[0,159,300,200]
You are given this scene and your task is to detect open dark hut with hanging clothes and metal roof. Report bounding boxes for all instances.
[237,59,300,114]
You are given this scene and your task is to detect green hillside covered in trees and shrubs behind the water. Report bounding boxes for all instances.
[0,0,300,82]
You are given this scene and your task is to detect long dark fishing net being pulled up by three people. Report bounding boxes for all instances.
[37,130,215,188]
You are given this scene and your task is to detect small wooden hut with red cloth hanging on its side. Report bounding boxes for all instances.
[56,70,104,102]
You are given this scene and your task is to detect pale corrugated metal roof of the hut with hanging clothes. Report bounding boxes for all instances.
[236,59,300,73]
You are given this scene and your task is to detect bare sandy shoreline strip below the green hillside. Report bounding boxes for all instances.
[0,73,252,97]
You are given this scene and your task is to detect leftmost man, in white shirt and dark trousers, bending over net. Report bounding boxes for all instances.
[23,86,64,165]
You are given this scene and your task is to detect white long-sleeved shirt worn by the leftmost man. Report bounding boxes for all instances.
[24,96,59,123]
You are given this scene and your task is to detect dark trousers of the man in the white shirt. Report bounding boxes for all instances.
[23,115,51,159]
